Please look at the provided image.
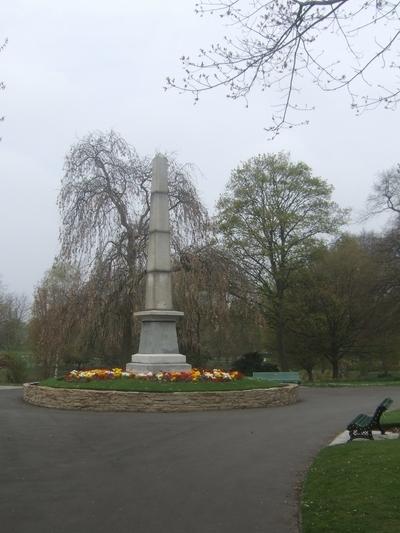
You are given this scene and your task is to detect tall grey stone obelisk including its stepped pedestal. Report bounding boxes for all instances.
[126,155,192,373]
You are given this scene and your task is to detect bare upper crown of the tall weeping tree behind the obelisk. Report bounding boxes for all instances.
[58,131,207,270]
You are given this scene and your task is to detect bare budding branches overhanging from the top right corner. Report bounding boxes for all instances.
[167,0,400,136]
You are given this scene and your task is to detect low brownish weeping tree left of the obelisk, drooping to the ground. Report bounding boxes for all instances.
[29,255,145,376]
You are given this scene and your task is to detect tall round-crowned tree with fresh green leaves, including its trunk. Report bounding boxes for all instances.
[217,153,347,369]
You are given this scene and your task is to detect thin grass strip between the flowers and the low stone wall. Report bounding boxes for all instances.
[40,378,277,392]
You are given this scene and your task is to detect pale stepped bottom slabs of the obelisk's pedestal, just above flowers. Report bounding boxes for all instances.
[126,353,192,374]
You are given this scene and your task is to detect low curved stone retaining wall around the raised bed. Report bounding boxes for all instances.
[24,383,298,413]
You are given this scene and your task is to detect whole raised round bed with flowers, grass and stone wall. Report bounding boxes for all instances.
[24,368,298,412]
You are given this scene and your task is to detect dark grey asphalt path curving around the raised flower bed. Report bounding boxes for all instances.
[0,387,400,533]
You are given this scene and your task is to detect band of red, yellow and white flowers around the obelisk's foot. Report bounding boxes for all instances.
[65,368,243,383]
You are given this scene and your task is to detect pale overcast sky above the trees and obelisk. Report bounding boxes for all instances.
[0,0,400,296]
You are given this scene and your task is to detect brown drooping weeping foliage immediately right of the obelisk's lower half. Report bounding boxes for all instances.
[173,242,263,366]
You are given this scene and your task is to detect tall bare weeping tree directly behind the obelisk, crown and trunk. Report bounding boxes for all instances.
[58,131,207,356]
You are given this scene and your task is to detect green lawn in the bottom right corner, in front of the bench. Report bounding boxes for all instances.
[301,436,400,533]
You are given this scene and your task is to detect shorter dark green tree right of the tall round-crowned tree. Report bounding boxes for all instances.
[290,235,386,378]
